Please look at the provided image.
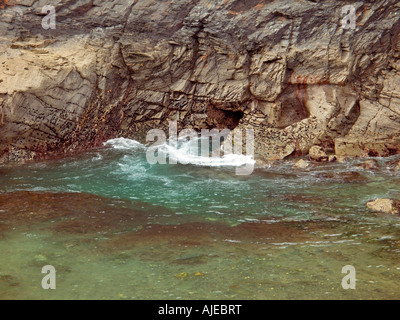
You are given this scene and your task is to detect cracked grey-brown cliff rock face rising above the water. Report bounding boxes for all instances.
[0,0,400,161]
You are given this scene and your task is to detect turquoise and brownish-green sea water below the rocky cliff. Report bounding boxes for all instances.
[0,139,400,300]
